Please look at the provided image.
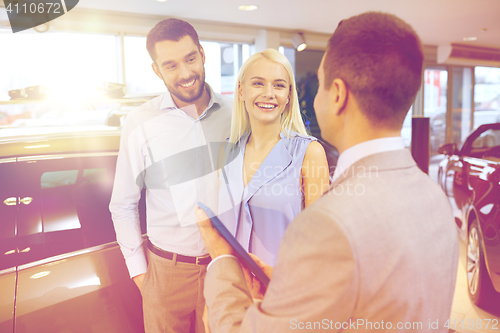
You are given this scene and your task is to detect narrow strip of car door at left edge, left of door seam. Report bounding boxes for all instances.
[0,158,19,332]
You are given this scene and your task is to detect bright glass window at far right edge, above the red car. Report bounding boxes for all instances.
[474,67,500,129]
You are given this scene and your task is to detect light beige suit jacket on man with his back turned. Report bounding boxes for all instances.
[205,150,458,333]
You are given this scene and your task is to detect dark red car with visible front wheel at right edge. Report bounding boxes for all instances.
[438,123,500,307]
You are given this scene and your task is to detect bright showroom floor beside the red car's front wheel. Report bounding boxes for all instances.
[429,156,500,333]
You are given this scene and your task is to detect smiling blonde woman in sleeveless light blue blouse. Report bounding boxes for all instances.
[219,49,329,265]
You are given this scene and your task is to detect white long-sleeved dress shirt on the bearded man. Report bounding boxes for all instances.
[110,85,232,277]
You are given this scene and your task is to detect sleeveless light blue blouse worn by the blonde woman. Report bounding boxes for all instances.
[219,132,316,266]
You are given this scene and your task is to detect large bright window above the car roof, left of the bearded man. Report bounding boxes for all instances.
[0,32,119,126]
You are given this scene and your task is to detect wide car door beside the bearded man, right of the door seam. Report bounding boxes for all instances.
[15,152,144,333]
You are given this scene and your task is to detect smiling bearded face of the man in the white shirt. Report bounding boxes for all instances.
[153,36,205,107]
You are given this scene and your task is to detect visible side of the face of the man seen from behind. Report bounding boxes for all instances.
[314,55,335,145]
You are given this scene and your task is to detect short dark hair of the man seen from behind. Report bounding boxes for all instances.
[323,12,424,127]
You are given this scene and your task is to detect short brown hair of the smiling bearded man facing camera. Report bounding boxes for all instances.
[146,18,200,61]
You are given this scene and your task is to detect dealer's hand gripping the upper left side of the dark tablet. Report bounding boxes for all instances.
[195,206,234,260]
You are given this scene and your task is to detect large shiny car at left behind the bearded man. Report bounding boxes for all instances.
[0,126,145,333]
